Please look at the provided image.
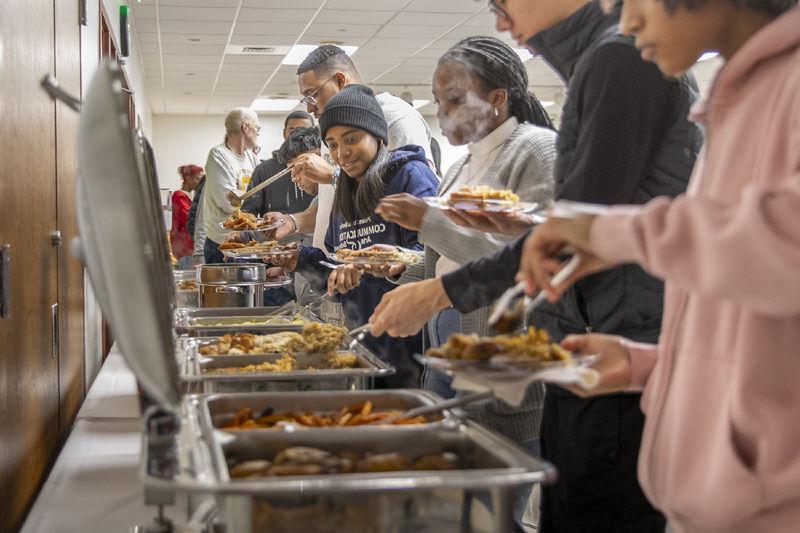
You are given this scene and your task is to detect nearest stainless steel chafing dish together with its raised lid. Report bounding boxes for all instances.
[78,63,554,533]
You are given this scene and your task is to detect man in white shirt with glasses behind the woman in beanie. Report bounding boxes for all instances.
[278,44,433,250]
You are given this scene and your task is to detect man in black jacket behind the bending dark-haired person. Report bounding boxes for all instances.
[242,111,314,216]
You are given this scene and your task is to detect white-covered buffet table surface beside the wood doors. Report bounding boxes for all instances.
[22,347,188,533]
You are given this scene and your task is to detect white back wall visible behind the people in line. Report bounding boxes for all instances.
[150,111,467,190]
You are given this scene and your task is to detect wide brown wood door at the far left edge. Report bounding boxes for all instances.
[0,0,60,532]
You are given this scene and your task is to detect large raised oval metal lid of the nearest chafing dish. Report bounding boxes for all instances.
[77,62,180,407]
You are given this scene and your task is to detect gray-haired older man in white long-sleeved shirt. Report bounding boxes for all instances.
[202,107,261,263]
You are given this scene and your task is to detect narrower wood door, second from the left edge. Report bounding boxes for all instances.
[55,0,86,437]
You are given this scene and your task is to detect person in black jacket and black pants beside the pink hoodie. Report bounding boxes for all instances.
[371,0,702,533]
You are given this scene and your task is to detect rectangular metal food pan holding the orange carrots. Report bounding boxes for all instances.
[200,389,457,431]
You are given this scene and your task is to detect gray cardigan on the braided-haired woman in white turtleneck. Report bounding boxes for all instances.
[400,123,556,442]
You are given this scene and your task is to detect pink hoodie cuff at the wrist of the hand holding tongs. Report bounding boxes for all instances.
[589,207,639,263]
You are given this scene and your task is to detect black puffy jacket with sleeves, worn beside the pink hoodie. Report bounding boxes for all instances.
[443,2,702,342]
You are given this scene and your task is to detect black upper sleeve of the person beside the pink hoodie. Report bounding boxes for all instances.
[556,42,679,204]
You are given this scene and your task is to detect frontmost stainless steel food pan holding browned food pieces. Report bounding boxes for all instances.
[212,422,555,533]
